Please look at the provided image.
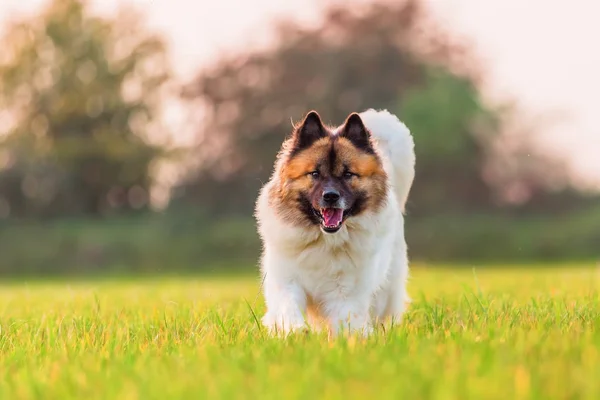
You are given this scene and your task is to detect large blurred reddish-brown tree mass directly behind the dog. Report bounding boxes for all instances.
[177,0,576,215]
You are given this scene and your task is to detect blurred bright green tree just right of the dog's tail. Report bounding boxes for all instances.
[398,68,498,214]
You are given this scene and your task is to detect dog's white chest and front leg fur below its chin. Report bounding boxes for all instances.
[262,194,403,330]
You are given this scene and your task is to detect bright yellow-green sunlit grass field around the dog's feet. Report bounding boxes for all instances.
[0,266,600,400]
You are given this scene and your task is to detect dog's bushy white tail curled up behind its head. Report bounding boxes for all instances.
[360,109,415,212]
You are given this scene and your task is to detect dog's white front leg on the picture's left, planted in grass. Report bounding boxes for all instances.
[262,275,306,334]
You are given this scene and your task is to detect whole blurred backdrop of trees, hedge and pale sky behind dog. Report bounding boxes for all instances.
[0,0,600,277]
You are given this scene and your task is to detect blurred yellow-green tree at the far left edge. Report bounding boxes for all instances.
[0,0,169,216]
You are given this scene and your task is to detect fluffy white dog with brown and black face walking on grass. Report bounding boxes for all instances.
[255,109,415,335]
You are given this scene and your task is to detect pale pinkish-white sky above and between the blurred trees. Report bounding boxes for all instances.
[0,0,600,189]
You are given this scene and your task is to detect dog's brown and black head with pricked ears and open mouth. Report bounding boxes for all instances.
[271,111,387,233]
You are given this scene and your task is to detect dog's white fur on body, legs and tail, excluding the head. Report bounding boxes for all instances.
[256,110,415,334]
